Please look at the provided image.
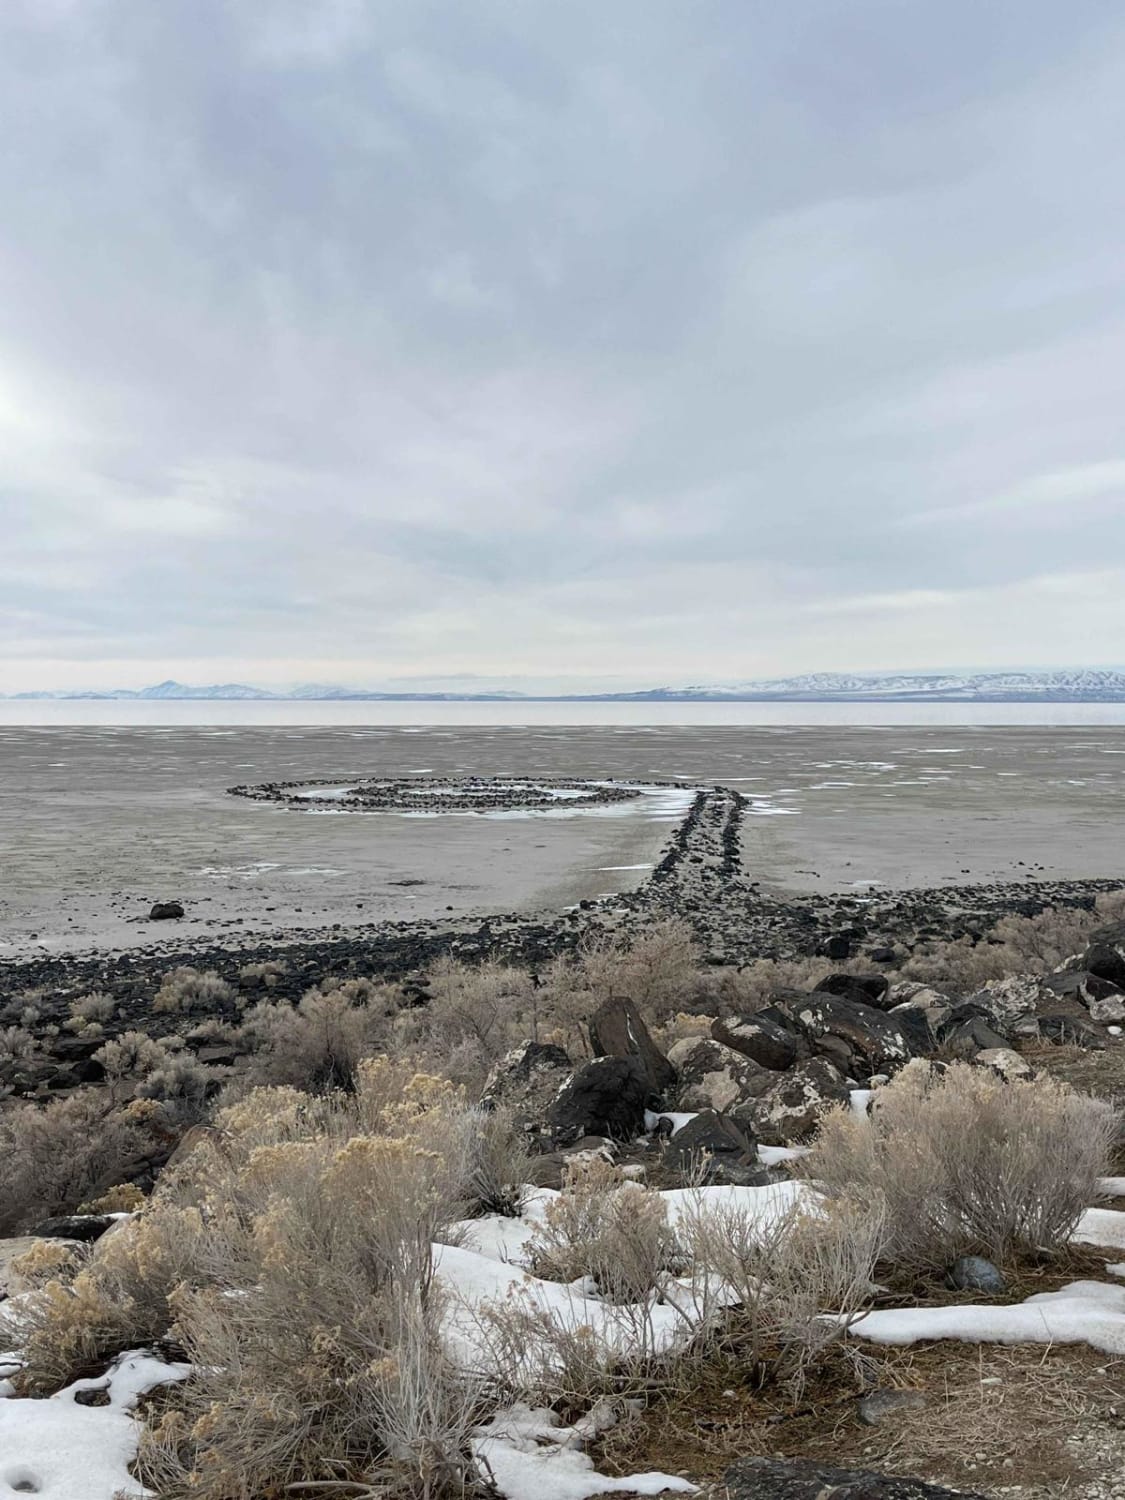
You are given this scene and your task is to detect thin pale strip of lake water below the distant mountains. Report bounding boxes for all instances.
[0,699,1125,729]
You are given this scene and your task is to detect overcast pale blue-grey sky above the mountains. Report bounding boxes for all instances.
[0,0,1125,693]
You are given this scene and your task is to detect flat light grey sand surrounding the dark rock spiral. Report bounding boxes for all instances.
[0,726,1125,956]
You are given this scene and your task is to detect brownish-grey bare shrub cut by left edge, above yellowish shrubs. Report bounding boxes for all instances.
[0,1089,153,1235]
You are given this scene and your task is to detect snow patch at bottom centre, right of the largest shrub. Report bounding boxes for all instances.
[473,1404,696,1500]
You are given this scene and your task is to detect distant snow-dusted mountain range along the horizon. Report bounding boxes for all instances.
[11,668,1125,704]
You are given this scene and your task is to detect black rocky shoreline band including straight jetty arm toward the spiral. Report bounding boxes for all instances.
[0,786,1125,1016]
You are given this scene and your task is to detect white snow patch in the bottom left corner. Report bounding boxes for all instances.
[0,1350,189,1500]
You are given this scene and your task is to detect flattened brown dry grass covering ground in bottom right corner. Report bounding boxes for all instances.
[594,1343,1125,1496]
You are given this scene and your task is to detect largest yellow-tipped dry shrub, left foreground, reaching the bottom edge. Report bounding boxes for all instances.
[129,1062,489,1500]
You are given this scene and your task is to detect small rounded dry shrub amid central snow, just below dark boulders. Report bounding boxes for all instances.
[528,1160,684,1302]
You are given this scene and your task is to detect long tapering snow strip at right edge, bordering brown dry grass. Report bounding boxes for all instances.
[851,1281,1125,1355]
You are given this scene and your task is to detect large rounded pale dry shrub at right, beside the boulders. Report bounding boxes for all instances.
[800,1064,1118,1272]
